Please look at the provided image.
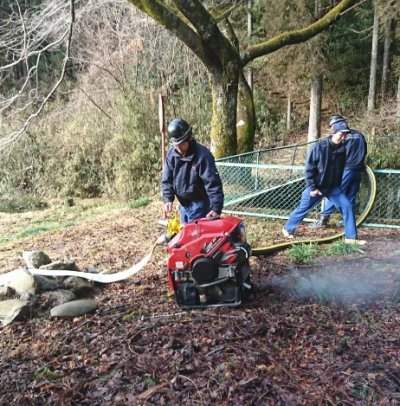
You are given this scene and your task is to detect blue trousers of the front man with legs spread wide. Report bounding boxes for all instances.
[284,187,357,239]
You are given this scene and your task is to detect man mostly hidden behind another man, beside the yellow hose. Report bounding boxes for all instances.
[311,114,367,228]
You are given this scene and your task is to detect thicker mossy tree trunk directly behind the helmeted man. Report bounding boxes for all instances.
[210,71,239,158]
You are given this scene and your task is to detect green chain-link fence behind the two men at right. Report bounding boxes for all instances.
[217,143,400,228]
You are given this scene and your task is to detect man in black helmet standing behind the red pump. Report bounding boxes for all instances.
[161,118,224,223]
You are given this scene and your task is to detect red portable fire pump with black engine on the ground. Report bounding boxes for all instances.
[167,216,251,308]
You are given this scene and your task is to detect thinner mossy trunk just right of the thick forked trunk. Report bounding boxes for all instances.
[236,71,256,154]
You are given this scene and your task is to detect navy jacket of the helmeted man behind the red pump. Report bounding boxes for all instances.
[161,140,224,214]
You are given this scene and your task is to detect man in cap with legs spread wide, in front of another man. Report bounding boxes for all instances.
[282,122,365,245]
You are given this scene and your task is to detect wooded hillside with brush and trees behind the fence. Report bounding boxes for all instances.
[0,0,400,205]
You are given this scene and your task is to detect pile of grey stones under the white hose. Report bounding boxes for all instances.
[0,251,99,326]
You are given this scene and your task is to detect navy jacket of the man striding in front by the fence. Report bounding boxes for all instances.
[305,137,346,193]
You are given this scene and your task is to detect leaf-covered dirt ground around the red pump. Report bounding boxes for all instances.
[0,203,400,405]
